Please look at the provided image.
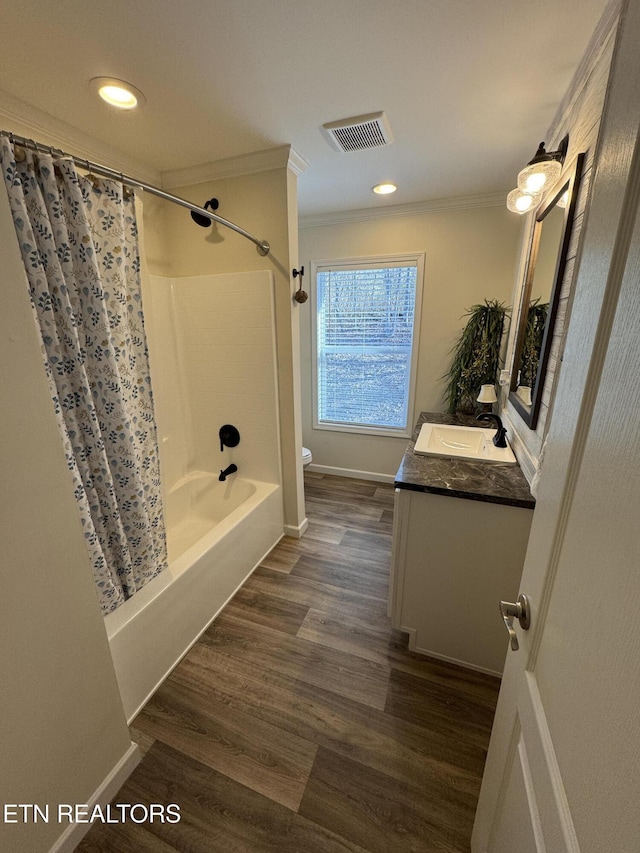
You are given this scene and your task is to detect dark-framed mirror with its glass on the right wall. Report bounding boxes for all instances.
[509,154,584,429]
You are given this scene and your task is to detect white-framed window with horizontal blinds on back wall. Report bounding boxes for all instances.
[312,255,423,436]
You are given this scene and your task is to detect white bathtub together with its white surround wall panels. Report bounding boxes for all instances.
[105,271,284,720]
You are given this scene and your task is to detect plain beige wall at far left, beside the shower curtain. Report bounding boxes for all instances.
[0,181,135,853]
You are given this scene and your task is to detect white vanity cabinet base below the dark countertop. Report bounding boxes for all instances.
[389,489,533,675]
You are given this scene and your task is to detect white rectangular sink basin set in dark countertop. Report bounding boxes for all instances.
[414,424,516,465]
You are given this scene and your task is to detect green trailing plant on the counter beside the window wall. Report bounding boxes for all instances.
[444,299,507,415]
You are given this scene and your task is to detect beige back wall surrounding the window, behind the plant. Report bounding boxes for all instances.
[300,201,522,478]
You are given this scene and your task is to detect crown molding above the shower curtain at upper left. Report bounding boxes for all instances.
[0,90,160,184]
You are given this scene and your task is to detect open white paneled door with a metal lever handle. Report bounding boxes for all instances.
[472,0,640,853]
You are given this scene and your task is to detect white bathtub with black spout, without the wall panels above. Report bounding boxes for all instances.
[104,471,283,722]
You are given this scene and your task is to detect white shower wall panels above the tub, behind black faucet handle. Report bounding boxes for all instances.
[144,270,281,492]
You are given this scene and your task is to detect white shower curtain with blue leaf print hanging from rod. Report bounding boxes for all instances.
[0,136,167,614]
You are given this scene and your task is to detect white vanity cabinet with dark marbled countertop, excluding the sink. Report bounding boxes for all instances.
[389,413,535,675]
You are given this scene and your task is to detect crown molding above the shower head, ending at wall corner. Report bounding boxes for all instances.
[162,145,309,189]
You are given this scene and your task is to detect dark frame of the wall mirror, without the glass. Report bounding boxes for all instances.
[509,154,585,429]
